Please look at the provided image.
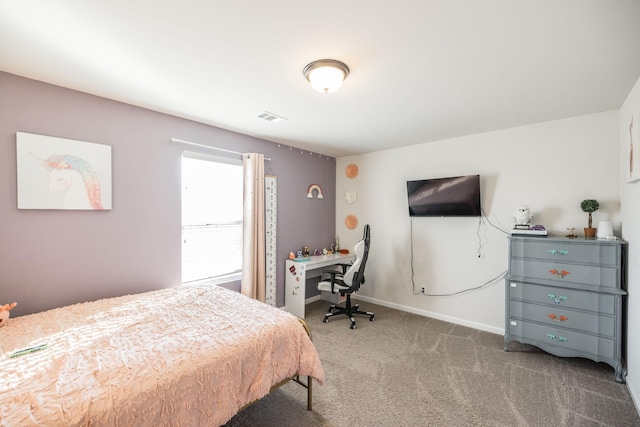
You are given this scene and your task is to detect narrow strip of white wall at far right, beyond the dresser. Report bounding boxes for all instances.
[620,75,640,412]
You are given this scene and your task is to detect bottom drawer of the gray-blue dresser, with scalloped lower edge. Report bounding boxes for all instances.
[509,319,616,361]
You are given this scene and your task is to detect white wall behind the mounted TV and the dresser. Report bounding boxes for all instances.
[336,110,620,334]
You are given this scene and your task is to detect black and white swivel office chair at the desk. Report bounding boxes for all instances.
[318,224,375,329]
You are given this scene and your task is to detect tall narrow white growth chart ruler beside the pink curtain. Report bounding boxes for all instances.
[264,175,278,307]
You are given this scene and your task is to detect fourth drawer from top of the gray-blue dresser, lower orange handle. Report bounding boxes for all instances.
[509,301,615,338]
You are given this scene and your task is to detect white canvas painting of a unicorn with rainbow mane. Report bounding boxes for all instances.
[16,132,111,210]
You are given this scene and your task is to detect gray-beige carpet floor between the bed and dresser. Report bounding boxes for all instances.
[227,301,640,427]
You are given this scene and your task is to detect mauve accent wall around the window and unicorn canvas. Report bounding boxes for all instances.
[0,72,336,315]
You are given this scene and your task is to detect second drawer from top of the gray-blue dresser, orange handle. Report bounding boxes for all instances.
[509,258,619,288]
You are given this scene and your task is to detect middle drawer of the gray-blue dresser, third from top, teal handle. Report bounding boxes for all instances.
[508,281,616,315]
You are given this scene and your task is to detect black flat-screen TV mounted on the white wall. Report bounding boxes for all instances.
[407,175,481,216]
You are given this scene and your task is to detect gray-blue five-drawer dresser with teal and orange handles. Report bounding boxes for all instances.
[504,236,626,382]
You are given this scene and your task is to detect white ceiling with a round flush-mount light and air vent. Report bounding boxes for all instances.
[0,0,640,156]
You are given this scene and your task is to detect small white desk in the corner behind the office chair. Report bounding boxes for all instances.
[284,254,356,319]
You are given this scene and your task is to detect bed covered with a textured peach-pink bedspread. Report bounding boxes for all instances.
[0,285,324,426]
